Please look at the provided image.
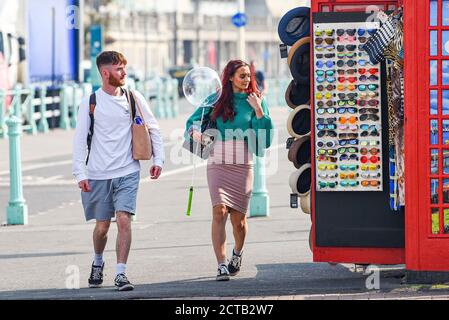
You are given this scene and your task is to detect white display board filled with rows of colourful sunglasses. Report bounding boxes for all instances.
[313,22,383,192]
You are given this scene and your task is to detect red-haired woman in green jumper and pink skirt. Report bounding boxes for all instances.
[186,60,273,281]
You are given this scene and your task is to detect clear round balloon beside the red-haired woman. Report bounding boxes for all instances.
[182,67,222,107]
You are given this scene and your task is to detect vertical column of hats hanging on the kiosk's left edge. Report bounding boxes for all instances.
[278,7,311,214]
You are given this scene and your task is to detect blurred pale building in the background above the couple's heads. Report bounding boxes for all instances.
[86,0,305,77]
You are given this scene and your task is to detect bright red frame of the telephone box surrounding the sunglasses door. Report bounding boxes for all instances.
[310,0,449,273]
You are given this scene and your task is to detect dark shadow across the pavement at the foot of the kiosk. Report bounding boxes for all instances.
[0,263,404,300]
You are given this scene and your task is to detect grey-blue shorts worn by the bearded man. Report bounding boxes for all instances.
[81,171,140,221]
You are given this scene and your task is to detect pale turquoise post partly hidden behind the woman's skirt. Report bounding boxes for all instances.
[249,156,270,217]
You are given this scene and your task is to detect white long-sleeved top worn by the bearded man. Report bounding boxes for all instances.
[72,88,165,182]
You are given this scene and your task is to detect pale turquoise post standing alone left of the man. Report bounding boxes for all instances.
[6,115,28,225]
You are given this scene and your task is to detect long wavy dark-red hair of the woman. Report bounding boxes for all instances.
[211,60,259,122]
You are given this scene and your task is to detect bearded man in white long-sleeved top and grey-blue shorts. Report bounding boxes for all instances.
[73,51,164,291]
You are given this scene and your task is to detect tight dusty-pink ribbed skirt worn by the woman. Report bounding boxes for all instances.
[207,140,253,214]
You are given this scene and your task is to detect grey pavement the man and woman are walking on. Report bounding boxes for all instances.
[0,104,449,300]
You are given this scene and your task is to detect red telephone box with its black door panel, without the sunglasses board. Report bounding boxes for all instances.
[310,0,449,279]
